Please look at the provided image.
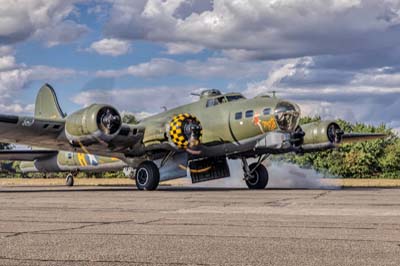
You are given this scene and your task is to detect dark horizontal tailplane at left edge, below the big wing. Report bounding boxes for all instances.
[0,150,58,161]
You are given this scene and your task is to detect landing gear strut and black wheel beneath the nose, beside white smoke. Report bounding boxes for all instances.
[242,155,268,189]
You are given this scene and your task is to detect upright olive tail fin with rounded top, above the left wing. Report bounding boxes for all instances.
[35,84,65,120]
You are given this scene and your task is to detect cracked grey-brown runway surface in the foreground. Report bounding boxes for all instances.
[0,187,400,266]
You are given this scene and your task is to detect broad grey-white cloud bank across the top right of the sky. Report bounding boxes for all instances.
[105,0,400,59]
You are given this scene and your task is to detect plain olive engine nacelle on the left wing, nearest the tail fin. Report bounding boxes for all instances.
[65,104,122,146]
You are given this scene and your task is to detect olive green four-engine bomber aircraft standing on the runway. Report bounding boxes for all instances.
[0,84,384,190]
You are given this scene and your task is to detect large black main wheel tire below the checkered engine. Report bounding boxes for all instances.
[135,161,160,190]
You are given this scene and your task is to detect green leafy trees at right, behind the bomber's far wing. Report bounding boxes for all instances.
[284,117,400,178]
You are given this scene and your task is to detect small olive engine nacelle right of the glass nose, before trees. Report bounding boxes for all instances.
[301,121,343,147]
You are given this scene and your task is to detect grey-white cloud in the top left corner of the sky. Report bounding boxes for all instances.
[0,0,88,46]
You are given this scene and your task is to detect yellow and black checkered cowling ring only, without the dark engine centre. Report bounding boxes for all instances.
[169,113,202,149]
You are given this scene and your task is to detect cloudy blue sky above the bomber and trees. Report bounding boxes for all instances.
[0,0,400,130]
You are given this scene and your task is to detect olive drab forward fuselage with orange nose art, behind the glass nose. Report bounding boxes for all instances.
[138,93,292,148]
